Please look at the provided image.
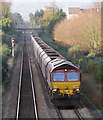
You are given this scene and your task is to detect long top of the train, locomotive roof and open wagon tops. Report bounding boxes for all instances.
[31,37,78,71]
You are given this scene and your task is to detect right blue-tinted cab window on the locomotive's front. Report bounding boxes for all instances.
[67,72,79,81]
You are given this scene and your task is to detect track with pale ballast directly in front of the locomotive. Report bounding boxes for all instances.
[55,94,102,120]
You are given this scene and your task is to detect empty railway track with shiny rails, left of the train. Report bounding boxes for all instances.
[16,32,38,120]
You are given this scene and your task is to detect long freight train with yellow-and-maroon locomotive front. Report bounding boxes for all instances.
[31,35,81,105]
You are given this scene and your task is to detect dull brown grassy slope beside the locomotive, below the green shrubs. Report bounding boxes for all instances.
[81,73,102,109]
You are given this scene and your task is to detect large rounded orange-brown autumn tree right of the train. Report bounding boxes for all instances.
[54,9,101,55]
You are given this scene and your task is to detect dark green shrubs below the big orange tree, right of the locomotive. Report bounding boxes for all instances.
[78,58,103,83]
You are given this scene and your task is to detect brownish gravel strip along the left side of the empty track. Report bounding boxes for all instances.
[2,32,23,118]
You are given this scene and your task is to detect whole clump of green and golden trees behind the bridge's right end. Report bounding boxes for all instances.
[29,4,66,34]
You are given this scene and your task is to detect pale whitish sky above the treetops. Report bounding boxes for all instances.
[10,0,100,20]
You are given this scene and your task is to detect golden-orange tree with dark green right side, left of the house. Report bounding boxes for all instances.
[42,6,66,34]
